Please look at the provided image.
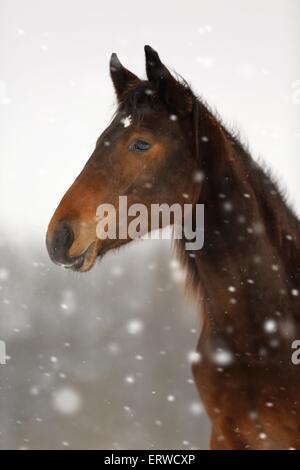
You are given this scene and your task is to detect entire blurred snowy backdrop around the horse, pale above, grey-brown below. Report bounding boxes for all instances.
[0,0,300,449]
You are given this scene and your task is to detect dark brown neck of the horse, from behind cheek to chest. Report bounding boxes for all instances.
[179,103,300,352]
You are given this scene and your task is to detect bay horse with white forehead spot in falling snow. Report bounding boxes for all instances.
[46,46,300,449]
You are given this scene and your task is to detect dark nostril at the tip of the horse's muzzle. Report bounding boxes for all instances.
[46,221,74,264]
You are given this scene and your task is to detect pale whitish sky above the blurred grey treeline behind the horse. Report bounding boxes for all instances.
[0,0,300,241]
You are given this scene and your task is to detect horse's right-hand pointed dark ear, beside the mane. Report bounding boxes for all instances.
[145,46,193,114]
